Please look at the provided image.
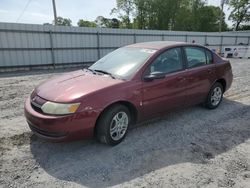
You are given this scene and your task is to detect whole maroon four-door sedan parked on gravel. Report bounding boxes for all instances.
[25,42,232,145]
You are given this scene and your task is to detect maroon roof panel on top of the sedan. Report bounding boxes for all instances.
[126,41,195,50]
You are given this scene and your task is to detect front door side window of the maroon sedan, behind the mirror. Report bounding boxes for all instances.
[150,48,183,74]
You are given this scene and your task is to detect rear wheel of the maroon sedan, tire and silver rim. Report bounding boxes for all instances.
[205,82,223,109]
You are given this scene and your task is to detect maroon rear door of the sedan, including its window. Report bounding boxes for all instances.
[184,46,216,105]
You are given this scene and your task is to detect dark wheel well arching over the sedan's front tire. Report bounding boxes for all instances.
[94,101,137,134]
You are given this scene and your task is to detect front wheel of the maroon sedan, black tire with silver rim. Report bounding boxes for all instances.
[96,105,131,146]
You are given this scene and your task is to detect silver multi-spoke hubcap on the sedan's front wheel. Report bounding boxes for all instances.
[110,112,128,141]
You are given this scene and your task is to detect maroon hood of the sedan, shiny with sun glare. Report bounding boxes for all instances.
[35,70,124,103]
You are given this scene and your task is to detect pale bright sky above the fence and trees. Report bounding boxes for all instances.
[0,0,231,26]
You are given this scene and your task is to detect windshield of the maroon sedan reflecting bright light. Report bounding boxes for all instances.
[89,47,156,79]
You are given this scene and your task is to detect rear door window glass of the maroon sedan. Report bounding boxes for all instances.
[185,47,207,68]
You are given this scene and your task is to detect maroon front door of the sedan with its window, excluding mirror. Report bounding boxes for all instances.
[143,48,187,117]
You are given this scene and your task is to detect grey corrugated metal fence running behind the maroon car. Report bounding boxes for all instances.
[0,23,250,70]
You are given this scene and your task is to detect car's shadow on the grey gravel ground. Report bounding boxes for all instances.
[30,99,250,187]
